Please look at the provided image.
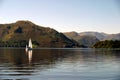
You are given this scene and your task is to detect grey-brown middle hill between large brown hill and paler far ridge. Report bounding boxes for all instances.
[64,32,99,47]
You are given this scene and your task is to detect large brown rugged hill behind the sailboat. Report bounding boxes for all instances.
[0,21,80,48]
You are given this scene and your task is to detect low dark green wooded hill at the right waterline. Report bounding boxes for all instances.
[93,40,120,48]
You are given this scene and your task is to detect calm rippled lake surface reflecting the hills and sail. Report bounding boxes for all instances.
[0,48,120,80]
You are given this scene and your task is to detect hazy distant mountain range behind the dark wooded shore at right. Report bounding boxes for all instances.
[64,32,120,47]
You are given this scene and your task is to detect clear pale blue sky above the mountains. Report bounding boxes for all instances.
[0,0,120,34]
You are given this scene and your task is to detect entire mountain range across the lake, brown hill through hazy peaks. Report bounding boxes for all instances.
[0,20,120,47]
